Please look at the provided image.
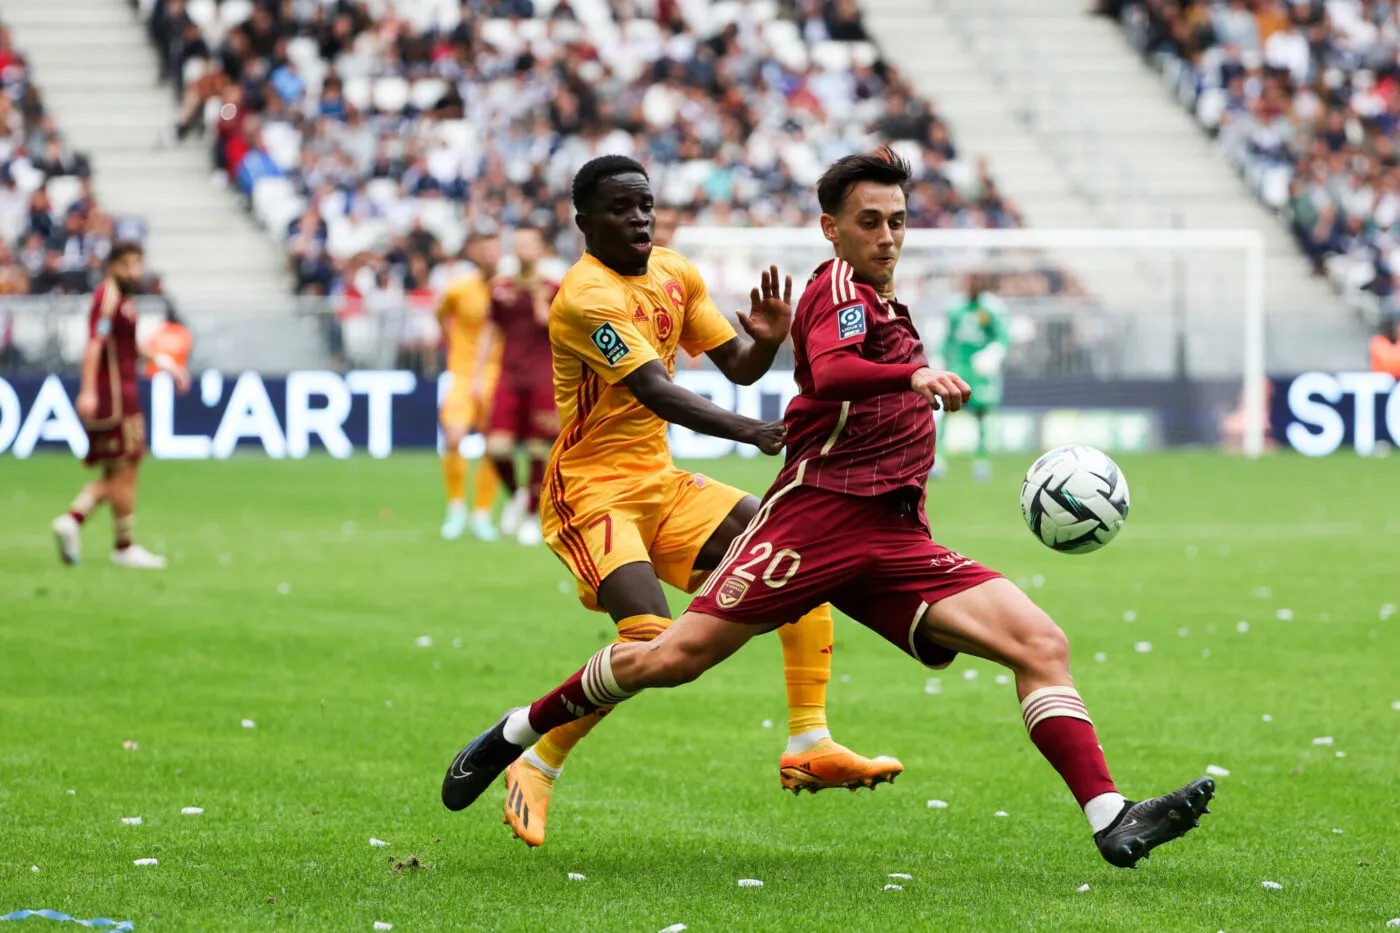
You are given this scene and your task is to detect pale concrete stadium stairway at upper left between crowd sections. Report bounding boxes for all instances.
[0,0,291,305]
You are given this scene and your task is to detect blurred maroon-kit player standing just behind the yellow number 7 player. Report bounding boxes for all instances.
[482,227,559,546]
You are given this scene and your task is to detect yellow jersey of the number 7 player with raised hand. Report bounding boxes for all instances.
[546,247,736,487]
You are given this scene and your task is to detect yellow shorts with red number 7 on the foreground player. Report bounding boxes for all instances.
[539,468,749,611]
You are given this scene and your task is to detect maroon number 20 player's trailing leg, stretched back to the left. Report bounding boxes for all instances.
[442,612,774,821]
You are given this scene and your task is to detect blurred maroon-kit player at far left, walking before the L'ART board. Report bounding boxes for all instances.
[52,242,189,570]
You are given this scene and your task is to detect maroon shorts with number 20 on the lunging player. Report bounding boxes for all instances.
[690,486,1001,667]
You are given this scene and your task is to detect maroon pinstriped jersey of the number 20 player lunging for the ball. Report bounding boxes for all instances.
[773,259,934,496]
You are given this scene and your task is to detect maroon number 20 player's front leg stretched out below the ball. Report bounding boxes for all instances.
[910,577,1215,867]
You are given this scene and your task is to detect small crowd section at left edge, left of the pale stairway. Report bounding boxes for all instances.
[0,19,148,296]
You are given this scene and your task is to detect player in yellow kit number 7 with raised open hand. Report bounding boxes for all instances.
[487,156,903,845]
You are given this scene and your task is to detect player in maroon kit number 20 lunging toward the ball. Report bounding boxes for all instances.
[442,150,1214,867]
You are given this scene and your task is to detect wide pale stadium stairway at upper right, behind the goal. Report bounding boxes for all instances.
[865,0,1365,374]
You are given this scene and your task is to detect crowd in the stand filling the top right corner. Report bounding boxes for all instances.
[1125,0,1400,314]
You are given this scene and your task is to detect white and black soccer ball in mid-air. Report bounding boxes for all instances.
[1021,445,1128,553]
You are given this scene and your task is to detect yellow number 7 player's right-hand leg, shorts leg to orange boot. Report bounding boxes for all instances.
[669,474,904,793]
